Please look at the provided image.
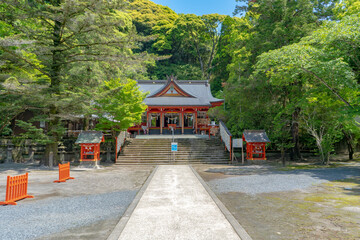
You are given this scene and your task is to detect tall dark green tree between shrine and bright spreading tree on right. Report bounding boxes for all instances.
[225,0,340,158]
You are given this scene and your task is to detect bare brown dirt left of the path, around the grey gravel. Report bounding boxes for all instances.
[0,164,154,239]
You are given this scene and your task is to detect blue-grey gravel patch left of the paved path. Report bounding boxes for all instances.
[0,191,137,240]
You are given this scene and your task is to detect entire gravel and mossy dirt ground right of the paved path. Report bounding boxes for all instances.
[194,163,360,240]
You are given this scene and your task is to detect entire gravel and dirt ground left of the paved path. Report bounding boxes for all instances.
[0,164,154,240]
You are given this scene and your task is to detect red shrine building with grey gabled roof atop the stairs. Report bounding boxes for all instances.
[128,77,224,135]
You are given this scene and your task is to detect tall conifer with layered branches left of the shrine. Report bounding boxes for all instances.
[0,0,152,164]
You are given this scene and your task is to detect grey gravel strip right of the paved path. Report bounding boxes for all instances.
[207,167,360,195]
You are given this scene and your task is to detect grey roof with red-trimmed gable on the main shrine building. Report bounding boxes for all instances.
[137,78,224,107]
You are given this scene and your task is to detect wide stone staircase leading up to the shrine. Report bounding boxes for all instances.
[116,138,229,165]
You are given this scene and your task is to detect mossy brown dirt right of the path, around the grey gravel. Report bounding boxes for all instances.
[194,163,360,240]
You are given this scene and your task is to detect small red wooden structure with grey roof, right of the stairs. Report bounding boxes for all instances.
[243,130,270,160]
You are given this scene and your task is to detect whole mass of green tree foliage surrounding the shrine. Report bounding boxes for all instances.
[0,0,360,163]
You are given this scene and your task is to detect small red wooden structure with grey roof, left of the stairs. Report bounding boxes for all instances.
[75,131,105,165]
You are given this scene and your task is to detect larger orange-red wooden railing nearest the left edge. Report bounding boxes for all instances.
[0,173,34,205]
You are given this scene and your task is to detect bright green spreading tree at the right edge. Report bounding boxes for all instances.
[255,15,360,162]
